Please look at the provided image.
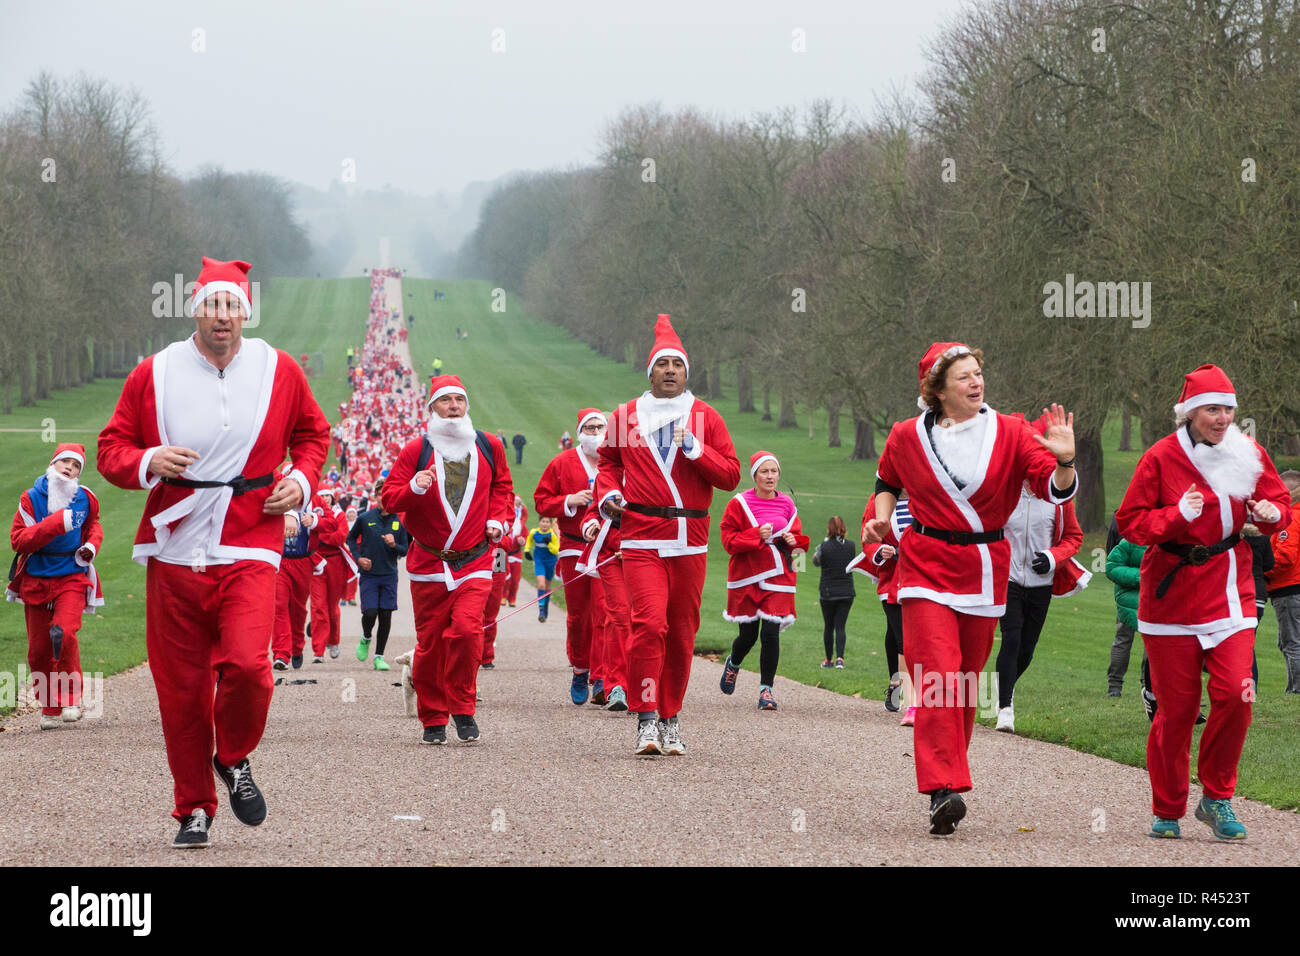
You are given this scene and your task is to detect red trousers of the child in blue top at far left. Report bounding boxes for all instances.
[21,575,87,717]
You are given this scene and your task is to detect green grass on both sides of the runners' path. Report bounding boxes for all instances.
[0,278,1300,808]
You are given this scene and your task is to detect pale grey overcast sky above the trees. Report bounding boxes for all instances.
[0,0,969,194]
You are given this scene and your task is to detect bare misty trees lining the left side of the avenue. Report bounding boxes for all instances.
[0,74,311,414]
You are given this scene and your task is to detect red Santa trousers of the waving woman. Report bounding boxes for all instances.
[902,598,997,793]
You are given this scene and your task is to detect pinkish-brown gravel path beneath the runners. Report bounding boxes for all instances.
[0,567,1300,866]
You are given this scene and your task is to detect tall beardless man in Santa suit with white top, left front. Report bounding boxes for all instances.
[98,256,329,848]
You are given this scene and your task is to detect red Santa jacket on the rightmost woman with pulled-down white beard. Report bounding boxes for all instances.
[1115,427,1291,634]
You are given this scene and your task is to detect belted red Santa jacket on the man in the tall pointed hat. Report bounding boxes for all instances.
[595,392,740,557]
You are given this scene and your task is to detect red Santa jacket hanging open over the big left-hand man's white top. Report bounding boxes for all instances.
[96,339,329,568]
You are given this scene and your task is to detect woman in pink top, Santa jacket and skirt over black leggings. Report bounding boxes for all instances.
[719,451,809,710]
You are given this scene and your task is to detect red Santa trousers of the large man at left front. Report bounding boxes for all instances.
[144,558,276,819]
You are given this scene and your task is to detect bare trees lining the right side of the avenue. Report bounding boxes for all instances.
[462,0,1300,529]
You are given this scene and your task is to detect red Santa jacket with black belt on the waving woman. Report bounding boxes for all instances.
[878,406,1078,618]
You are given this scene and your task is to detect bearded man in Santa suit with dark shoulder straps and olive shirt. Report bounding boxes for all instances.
[380,375,514,744]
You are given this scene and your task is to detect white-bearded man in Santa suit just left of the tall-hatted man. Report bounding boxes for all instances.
[533,408,606,704]
